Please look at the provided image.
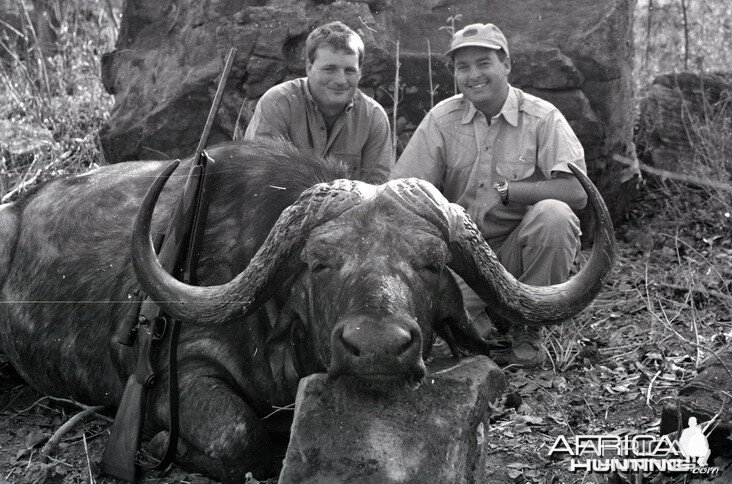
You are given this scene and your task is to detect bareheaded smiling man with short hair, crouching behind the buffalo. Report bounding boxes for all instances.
[244,22,394,183]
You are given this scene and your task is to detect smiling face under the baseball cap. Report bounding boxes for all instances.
[453,47,511,116]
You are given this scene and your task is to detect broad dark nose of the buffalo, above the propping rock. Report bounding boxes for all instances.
[341,323,414,357]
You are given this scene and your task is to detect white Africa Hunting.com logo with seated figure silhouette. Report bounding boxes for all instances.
[549,417,719,475]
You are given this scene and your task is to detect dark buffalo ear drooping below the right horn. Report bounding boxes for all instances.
[434,269,489,357]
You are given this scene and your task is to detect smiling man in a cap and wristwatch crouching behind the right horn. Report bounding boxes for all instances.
[390,24,587,367]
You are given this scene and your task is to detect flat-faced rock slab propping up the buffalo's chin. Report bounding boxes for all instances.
[279,357,506,484]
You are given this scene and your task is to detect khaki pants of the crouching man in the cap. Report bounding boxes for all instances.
[453,200,581,336]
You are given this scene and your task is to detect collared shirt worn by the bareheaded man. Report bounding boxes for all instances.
[244,77,394,183]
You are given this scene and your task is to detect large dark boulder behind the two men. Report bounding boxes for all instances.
[102,0,635,220]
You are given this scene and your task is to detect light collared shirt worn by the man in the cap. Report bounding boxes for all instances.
[390,86,587,242]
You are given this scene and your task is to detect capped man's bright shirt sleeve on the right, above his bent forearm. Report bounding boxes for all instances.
[537,109,587,178]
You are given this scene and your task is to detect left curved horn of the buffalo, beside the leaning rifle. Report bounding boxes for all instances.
[132,164,374,324]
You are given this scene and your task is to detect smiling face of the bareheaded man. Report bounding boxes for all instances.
[305,45,361,115]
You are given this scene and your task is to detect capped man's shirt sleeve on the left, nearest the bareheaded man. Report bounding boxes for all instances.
[389,113,445,189]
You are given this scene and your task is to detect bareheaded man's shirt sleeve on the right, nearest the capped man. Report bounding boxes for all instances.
[361,106,394,184]
